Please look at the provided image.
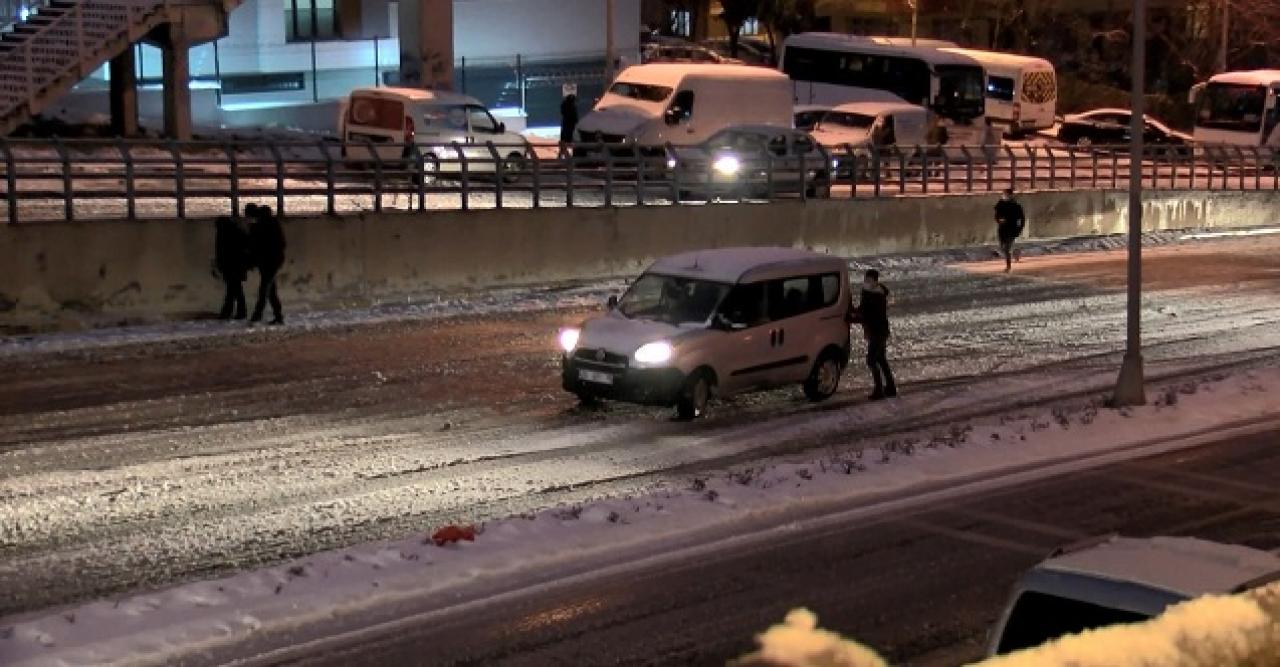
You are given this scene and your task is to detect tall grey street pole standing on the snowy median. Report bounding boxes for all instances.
[1112,0,1147,407]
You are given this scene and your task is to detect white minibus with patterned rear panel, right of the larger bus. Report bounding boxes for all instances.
[940,49,1057,136]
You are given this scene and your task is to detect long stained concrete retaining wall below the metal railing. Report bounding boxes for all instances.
[0,192,1280,330]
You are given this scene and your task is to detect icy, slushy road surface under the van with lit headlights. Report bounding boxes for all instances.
[0,236,1280,613]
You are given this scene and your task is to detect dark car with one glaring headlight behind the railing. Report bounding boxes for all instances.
[667,125,833,200]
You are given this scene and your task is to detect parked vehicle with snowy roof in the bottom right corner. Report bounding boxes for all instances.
[988,535,1280,655]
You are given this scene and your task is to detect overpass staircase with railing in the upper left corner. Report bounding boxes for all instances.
[0,0,241,136]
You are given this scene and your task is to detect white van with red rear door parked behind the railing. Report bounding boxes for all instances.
[338,88,532,174]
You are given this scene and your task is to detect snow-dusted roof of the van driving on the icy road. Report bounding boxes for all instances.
[649,247,846,283]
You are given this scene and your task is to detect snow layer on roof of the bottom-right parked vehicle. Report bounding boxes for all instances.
[1037,538,1280,598]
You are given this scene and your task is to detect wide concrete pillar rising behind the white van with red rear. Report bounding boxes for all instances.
[399,0,453,91]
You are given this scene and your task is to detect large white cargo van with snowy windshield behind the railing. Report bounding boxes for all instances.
[577,63,794,146]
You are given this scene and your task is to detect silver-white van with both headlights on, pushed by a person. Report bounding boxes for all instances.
[559,248,850,419]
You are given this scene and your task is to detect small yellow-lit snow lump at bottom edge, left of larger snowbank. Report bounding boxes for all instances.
[731,609,888,667]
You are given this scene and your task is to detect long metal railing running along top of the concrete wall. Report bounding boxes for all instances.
[0,140,1280,223]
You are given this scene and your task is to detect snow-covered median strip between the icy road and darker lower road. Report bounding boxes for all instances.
[0,367,1280,666]
